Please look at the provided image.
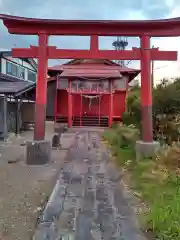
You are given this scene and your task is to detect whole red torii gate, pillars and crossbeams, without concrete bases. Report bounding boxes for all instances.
[0,14,180,143]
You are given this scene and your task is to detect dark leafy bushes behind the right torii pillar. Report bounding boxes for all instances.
[123,78,180,144]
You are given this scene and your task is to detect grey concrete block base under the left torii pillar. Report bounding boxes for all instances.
[26,140,52,165]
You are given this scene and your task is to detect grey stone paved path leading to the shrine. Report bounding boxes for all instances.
[34,131,145,240]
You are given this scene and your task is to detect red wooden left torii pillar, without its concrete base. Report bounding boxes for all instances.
[34,34,48,140]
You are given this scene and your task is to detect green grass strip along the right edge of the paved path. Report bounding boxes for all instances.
[104,127,180,240]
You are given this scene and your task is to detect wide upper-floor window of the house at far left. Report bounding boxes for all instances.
[6,61,25,79]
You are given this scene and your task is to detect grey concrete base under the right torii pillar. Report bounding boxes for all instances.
[136,141,160,159]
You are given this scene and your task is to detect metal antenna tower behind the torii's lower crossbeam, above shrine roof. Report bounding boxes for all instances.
[112,37,128,67]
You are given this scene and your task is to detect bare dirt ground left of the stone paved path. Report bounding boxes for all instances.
[0,122,71,240]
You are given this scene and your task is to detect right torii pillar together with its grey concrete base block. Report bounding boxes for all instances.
[136,35,160,158]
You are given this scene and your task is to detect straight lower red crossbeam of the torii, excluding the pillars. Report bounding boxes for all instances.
[12,46,177,61]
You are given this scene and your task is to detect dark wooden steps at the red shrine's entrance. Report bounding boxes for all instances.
[73,116,109,127]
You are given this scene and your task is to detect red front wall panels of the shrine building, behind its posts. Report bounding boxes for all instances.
[50,77,128,119]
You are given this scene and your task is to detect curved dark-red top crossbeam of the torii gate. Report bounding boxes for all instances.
[0,14,180,37]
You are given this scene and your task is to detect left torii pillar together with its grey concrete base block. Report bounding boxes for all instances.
[26,33,51,165]
